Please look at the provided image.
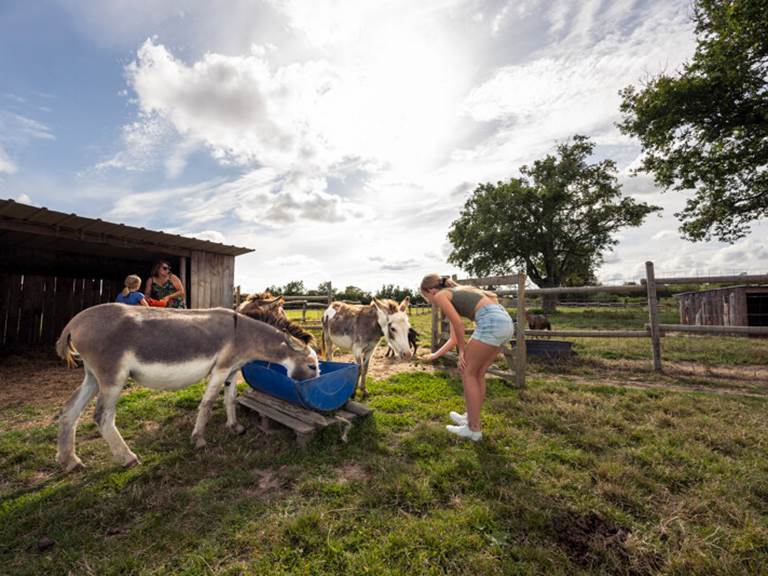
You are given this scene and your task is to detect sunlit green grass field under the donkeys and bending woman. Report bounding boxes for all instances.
[0,310,768,575]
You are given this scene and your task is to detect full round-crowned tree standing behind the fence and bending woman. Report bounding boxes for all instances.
[448,136,660,306]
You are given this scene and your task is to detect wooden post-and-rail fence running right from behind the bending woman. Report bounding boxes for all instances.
[432,262,768,387]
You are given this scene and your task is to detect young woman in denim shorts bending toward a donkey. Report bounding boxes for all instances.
[421,274,514,441]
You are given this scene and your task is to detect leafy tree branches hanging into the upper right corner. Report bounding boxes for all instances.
[619,0,768,242]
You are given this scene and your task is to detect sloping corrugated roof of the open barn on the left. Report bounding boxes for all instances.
[0,200,253,256]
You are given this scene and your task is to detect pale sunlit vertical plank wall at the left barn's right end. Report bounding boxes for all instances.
[189,251,235,308]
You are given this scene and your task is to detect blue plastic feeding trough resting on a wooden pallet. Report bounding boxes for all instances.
[242,360,359,412]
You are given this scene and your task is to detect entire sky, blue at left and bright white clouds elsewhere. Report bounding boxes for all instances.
[0,0,768,291]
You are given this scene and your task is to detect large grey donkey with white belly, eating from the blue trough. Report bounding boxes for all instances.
[56,304,319,471]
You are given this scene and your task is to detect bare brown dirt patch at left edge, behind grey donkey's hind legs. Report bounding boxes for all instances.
[0,350,83,409]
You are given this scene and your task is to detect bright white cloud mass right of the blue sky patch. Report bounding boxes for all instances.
[79,0,764,289]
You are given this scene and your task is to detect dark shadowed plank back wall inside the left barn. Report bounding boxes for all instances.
[0,273,122,346]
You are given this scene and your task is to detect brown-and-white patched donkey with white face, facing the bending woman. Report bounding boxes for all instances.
[322,296,412,397]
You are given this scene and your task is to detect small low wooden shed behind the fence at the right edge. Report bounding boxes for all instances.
[675,285,768,326]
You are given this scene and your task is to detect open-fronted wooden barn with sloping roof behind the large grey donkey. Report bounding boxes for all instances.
[0,200,251,346]
